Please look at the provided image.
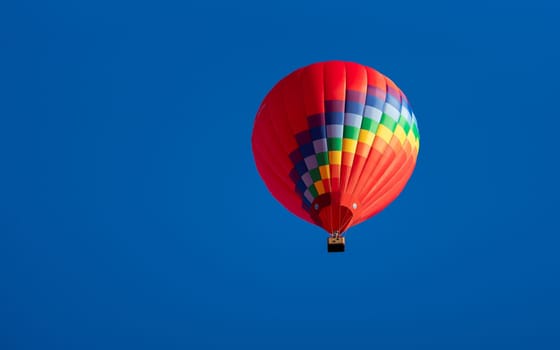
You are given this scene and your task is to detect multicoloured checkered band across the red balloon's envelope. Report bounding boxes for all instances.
[290,86,419,210]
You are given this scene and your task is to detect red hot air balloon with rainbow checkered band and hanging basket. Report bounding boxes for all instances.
[252,61,419,252]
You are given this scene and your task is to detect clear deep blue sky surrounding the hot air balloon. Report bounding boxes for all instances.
[0,0,560,350]
